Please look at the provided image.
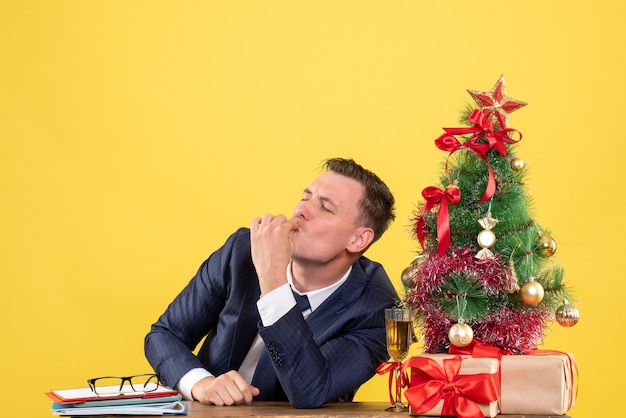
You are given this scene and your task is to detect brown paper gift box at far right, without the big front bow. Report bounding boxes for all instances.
[500,351,576,415]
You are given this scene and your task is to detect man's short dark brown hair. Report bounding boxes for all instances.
[323,158,396,247]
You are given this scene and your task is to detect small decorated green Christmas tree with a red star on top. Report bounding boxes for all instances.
[402,77,579,353]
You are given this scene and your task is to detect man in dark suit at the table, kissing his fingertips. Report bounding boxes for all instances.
[145,158,398,408]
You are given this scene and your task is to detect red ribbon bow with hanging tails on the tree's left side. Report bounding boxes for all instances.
[415,186,461,257]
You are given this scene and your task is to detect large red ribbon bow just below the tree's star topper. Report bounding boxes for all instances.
[435,109,522,203]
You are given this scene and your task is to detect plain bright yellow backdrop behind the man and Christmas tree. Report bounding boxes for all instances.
[0,0,626,418]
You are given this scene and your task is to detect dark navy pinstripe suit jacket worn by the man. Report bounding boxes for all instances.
[145,228,398,408]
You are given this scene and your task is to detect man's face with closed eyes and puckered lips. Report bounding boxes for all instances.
[291,171,364,263]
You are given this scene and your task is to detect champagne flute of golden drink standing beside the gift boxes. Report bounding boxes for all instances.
[385,308,413,412]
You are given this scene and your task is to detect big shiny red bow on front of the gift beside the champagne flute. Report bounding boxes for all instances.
[404,356,498,418]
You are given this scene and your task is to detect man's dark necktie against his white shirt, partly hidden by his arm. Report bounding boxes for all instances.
[252,292,311,401]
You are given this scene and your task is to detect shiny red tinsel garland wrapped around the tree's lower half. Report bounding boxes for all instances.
[406,247,552,352]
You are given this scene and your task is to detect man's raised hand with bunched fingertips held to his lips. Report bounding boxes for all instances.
[250,214,298,295]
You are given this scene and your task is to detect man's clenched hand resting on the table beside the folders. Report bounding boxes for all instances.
[191,370,259,406]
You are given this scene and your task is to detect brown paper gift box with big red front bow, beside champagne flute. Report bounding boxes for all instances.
[405,354,498,418]
